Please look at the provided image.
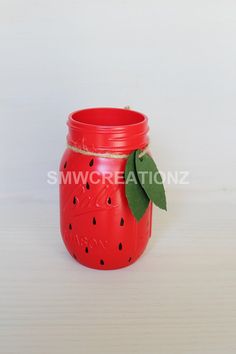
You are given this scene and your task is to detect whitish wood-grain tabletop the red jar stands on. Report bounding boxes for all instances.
[0,191,236,354]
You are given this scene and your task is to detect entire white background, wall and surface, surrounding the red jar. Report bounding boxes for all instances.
[0,0,236,354]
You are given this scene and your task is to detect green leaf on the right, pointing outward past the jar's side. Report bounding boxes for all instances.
[135,150,167,210]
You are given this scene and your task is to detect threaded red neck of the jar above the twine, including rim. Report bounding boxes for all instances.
[67,108,149,154]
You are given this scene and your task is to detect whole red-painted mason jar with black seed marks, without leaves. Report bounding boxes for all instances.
[60,108,152,269]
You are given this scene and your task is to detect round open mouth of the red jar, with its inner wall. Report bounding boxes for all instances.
[69,107,147,129]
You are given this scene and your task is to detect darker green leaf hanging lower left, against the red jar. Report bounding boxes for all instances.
[125,151,149,220]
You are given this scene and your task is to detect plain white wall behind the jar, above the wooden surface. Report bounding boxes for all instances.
[0,0,236,198]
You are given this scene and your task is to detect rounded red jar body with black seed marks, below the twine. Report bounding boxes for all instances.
[60,106,152,269]
